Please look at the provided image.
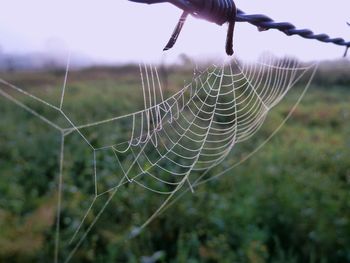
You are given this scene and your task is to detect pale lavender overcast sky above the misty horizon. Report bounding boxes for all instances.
[0,0,350,63]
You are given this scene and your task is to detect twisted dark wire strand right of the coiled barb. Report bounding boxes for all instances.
[236,9,350,56]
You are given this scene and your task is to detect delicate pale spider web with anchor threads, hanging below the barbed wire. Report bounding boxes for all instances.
[0,58,316,262]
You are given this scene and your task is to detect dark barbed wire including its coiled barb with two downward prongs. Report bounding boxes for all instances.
[129,0,350,57]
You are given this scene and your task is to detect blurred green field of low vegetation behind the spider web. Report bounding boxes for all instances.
[0,60,350,263]
